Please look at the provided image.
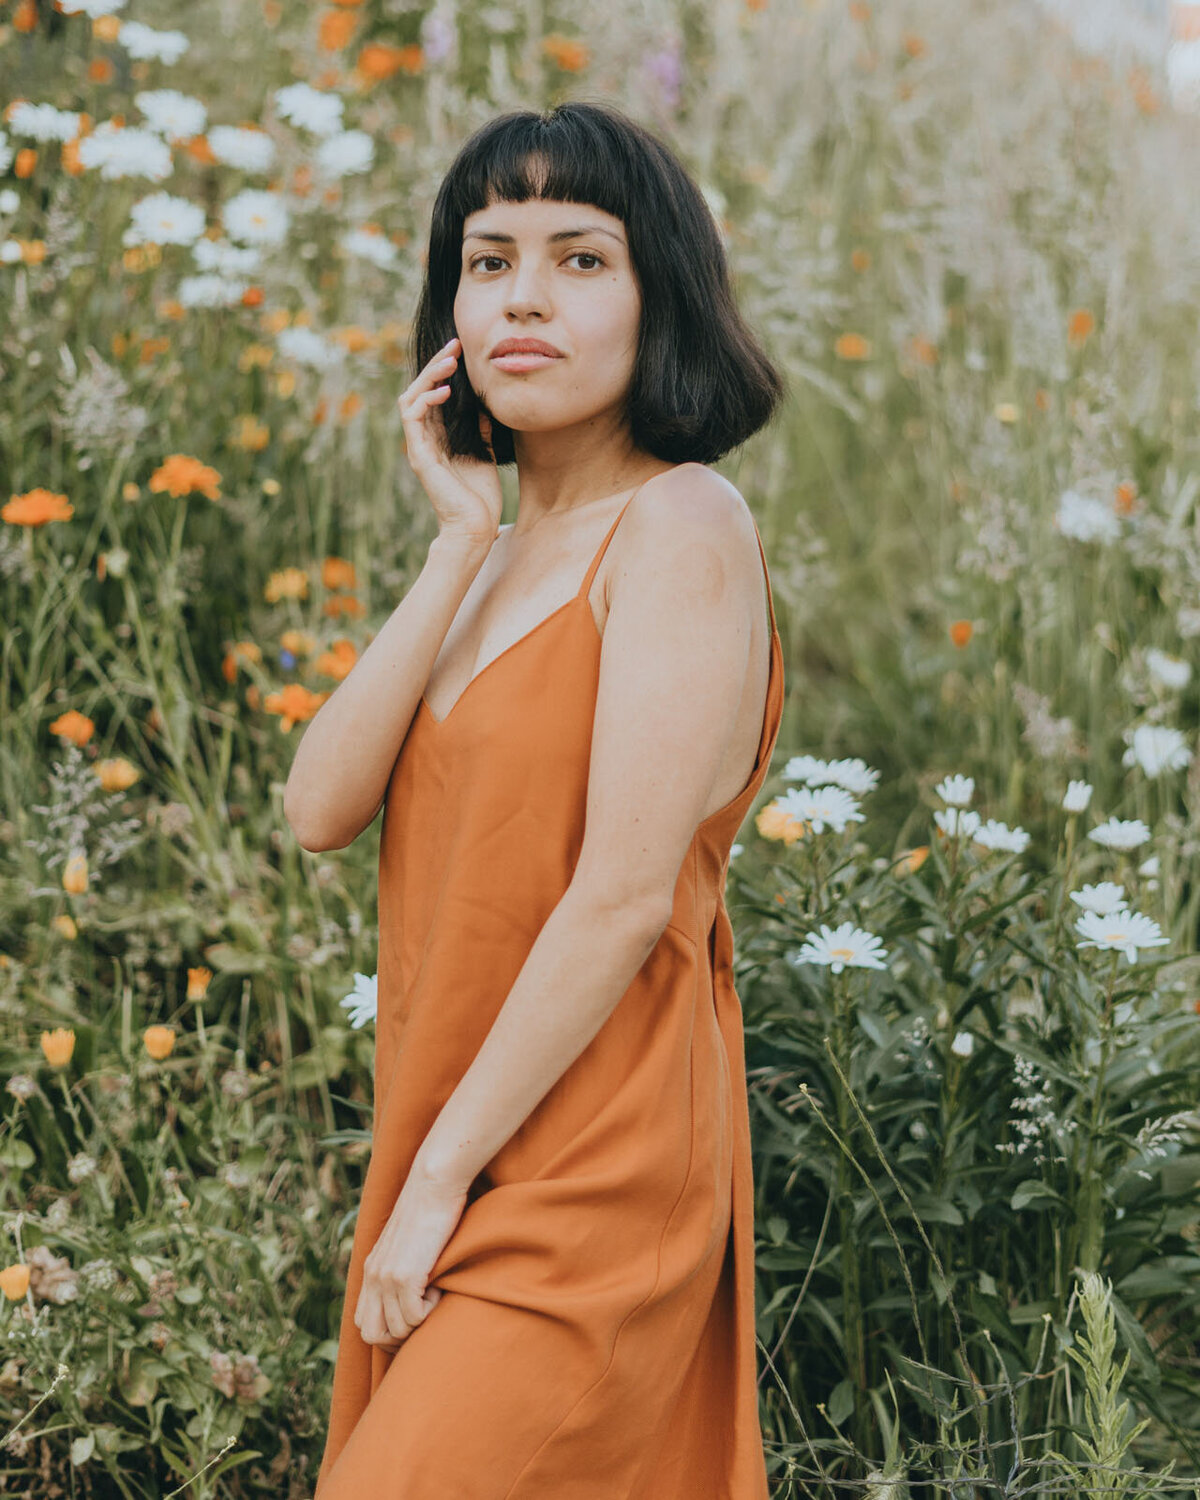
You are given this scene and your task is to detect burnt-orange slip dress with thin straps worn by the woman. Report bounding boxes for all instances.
[315,491,783,1500]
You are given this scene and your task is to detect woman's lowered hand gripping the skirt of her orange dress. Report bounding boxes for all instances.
[354,1163,467,1353]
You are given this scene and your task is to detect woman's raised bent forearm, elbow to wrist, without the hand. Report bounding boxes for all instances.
[284,534,491,852]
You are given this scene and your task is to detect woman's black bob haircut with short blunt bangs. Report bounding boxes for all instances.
[410,101,786,464]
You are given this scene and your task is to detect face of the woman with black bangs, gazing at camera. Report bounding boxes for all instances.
[455,198,642,432]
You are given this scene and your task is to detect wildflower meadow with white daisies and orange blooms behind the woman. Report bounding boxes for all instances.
[0,0,1200,1500]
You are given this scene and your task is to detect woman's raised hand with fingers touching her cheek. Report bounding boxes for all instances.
[398,338,504,546]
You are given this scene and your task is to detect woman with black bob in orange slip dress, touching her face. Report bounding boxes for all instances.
[285,102,783,1500]
